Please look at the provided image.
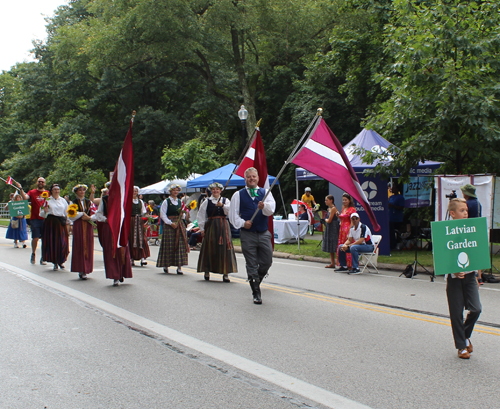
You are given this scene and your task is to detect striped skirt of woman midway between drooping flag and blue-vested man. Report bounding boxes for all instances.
[156,216,189,267]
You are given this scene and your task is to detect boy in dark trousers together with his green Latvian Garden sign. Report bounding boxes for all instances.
[431,199,490,359]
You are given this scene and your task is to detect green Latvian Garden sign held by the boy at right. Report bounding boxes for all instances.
[431,217,491,275]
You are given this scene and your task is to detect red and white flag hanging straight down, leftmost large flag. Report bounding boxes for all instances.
[108,120,134,251]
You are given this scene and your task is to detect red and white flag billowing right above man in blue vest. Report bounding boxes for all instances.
[292,118,380,231]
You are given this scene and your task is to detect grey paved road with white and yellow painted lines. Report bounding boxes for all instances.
[0,234,500,409]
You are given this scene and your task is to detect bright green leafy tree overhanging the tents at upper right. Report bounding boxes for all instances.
[367,0,500,174]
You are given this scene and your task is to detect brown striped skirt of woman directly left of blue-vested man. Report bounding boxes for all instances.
[197,216,238,274]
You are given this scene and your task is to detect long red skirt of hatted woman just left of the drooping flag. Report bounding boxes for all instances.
[71,219,94,274]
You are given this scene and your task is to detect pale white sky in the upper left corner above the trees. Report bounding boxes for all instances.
[0,0,67,72]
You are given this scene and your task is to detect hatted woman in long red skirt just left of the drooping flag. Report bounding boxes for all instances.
[68,185,95,280]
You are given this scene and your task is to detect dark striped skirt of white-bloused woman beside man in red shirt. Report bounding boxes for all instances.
[42,214,69,265]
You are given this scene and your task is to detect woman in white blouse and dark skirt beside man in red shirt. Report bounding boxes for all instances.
[40,183,69,271]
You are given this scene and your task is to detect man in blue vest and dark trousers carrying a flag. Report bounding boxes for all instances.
[229,168,276,304]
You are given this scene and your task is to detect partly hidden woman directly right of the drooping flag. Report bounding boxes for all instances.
[128,186,150,266]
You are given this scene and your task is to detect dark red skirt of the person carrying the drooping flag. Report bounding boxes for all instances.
[97,222,132,280]
